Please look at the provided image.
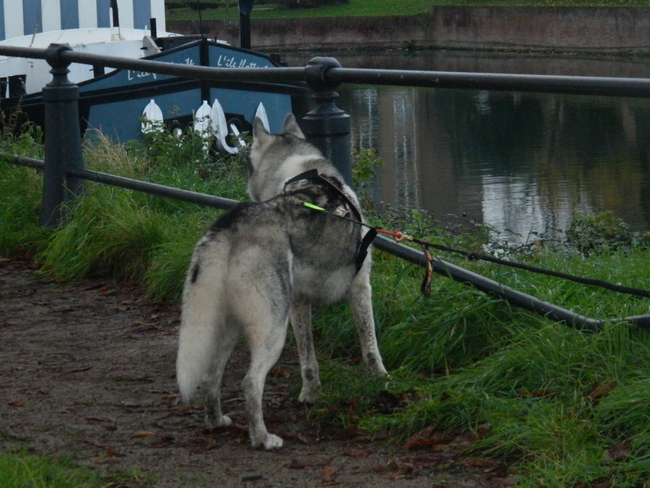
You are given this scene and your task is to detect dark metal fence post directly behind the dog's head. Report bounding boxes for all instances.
[302,57,352,186]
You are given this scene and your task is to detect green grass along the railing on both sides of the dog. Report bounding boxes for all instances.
[0,127,650,487]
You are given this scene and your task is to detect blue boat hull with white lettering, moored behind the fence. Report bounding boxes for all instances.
[3,38,309,142]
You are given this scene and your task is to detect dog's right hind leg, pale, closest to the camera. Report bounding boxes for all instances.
[242,312,288,450]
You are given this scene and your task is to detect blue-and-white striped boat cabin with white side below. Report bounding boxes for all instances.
[0,0,171,99]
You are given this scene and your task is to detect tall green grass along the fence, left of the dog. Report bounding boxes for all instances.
[0,126,239,301]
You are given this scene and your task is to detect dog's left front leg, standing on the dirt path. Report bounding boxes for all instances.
[290,300,321,403]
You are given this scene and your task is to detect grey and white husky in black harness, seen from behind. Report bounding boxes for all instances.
[176,114,386,449]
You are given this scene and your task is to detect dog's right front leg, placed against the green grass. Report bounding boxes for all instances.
[348,264,388,376]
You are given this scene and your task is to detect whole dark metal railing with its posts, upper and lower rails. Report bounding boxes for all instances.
[5,44,650,331]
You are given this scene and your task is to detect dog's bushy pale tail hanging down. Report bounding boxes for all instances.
[176,263,225,402]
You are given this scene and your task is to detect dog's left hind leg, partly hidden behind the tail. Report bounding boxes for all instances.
[203,330,238,428]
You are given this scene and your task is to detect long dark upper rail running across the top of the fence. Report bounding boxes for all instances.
[0,46,650,97]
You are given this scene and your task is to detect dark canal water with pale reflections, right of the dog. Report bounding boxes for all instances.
[290,49,650,243]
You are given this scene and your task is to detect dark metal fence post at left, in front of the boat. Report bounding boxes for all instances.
[41,44,83,227]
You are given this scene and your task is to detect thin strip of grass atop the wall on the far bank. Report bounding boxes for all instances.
[167,0,648,20]
